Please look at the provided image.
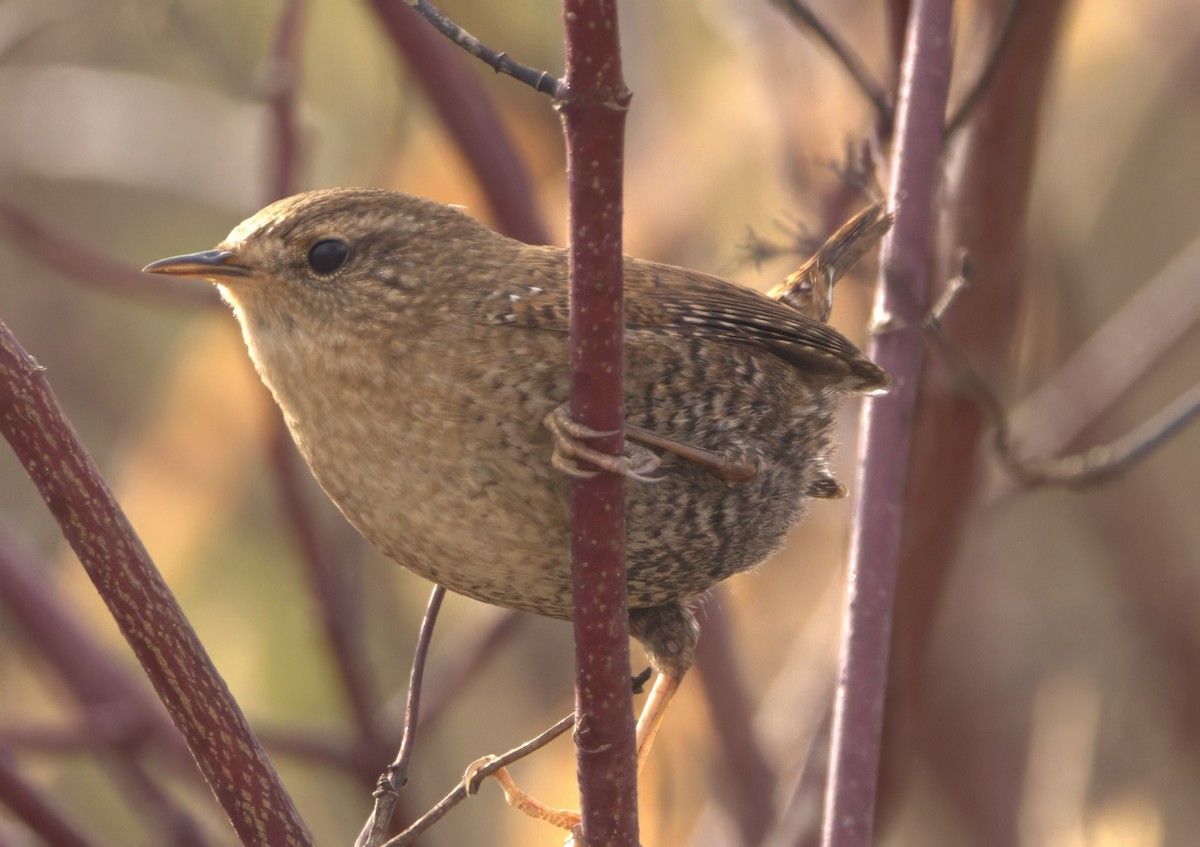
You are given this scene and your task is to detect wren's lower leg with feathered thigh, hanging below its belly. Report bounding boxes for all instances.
[629,603,700,773]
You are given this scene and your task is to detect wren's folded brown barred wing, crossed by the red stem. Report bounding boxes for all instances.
[480,248,892,394]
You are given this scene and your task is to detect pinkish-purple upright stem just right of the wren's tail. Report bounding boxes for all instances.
[823,0,953,847]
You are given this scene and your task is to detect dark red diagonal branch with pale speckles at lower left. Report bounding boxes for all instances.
[0,324,312,845]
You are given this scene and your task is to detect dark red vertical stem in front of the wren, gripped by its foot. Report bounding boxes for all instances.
[560,0,637,847]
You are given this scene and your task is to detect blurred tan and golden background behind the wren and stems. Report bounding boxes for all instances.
[0,0,1200,847]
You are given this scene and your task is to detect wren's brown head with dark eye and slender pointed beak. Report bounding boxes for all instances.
[145,188,505,335]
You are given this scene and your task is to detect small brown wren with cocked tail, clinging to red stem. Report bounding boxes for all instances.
[146,188,890,787]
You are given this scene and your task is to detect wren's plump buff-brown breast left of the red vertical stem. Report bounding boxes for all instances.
[241,309,570,615]
